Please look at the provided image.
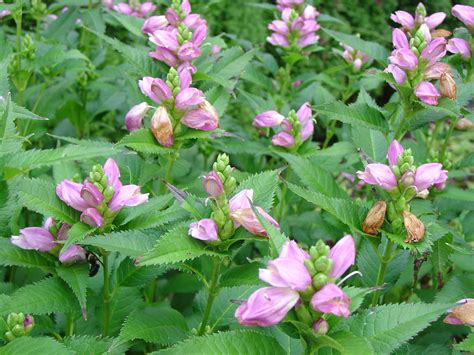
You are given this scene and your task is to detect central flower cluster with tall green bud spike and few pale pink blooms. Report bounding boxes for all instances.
[189,154,279,242]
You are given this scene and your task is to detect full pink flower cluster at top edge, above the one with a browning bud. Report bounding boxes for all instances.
[142,0,208,68]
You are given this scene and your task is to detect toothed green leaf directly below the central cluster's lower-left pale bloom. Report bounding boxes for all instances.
[140,222,222,266]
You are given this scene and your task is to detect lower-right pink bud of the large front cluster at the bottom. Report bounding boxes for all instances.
[311,284,351,318]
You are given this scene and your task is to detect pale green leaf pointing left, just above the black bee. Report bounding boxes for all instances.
[81,230,156,257]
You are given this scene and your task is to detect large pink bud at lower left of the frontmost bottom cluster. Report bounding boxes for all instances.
[235,287,300,327]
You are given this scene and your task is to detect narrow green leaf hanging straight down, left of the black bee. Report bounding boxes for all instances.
[56,264,89,319]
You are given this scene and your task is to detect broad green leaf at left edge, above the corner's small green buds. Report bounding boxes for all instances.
[0,277,77,314]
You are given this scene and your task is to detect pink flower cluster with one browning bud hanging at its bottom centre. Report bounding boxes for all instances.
[125,67,219,147]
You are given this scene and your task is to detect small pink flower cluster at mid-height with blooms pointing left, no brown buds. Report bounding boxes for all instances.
[252,102,314,150]
